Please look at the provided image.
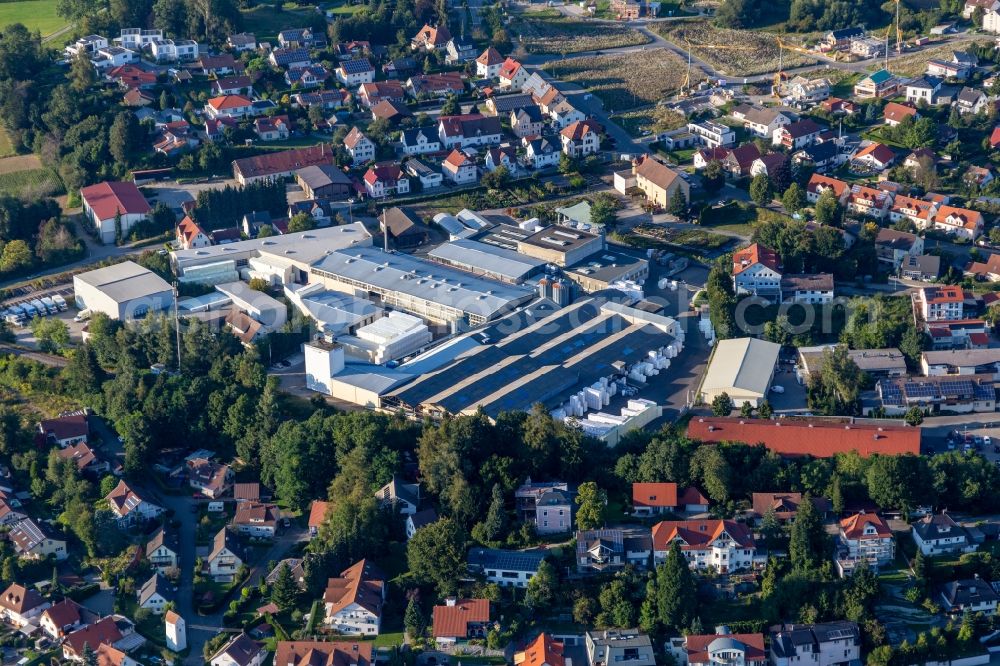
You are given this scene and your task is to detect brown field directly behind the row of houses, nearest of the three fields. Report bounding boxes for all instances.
[545,49,702,113]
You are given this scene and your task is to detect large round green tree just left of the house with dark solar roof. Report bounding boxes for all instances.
[406,518,465,596]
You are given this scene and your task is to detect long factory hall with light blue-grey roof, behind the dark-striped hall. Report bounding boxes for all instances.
[309,247,534,327]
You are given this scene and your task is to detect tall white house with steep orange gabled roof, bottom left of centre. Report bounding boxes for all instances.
[323,560,386,636]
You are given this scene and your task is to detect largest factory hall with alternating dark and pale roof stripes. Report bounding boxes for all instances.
[381,297,683,418]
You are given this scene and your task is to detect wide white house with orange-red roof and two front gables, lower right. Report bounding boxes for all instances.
[653,520,757,573]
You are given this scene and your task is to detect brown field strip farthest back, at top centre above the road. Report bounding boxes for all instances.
[511,9,649,53]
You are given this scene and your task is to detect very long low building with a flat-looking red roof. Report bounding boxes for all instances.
[687,417,920,458]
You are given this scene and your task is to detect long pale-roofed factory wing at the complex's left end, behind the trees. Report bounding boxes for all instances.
[170,222,372,284]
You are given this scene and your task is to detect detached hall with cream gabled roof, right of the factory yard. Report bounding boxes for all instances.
[701,338,781,407]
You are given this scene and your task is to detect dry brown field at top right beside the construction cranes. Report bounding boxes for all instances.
[652,21,817,76]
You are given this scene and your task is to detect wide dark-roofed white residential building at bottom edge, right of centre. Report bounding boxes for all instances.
[768,620,861,666]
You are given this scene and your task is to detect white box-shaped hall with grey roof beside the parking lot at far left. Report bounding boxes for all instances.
[73,261,173,321]
